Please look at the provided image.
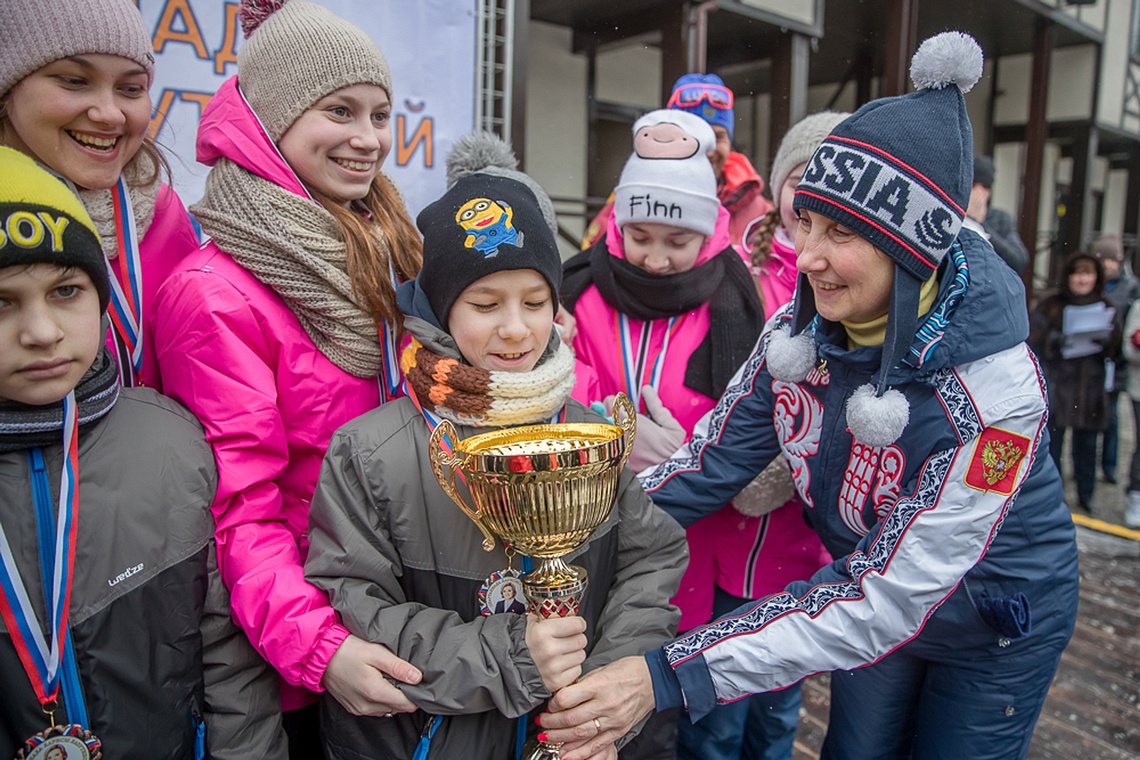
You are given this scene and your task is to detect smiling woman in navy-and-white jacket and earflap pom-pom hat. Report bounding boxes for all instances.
[542,32,1077,760]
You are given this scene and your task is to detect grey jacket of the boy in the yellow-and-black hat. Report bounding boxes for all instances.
[0,389,287,760]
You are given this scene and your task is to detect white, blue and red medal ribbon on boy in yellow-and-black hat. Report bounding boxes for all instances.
[0,391,79,708]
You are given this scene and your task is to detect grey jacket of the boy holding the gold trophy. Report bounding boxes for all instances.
[306,399,687,760]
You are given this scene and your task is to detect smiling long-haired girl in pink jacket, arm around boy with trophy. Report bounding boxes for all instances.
[147,0,422,758]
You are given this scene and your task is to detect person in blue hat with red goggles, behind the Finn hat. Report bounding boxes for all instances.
[581,74,772,254]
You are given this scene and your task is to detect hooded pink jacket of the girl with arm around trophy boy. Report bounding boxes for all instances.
[154,79,381,710]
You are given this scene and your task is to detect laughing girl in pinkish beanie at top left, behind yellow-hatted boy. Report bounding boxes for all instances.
[0,0,198,386]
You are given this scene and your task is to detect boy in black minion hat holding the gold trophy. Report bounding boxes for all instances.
[306,134,684,760]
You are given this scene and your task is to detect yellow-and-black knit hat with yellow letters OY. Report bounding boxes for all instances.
[0,147,111,311]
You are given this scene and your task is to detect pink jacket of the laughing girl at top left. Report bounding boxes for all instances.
[107,185,198,391]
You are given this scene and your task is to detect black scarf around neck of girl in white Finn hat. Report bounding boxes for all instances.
[562,236,764,399]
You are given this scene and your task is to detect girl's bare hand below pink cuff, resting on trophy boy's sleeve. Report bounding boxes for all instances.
[320,635,423,718]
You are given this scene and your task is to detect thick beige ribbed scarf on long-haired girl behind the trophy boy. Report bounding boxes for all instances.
[190,158,380,377]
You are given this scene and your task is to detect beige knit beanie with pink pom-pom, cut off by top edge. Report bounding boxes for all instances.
[237,0,392,142]
